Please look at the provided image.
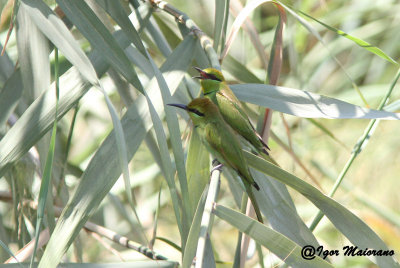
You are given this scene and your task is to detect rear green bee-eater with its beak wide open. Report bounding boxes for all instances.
[194,67,269,156]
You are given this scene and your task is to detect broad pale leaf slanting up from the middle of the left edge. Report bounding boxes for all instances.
[0,23,149,176]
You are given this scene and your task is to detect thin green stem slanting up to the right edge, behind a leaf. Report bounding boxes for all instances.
[310,69,400,231]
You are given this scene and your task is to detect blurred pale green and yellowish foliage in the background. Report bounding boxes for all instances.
[0,0,400,267]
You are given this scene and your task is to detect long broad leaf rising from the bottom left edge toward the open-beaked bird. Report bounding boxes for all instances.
[39,36,193,267]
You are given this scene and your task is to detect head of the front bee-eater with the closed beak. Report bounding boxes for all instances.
[168,98,221,125]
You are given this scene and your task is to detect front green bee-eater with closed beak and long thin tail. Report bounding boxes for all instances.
[168,98,263,223]
